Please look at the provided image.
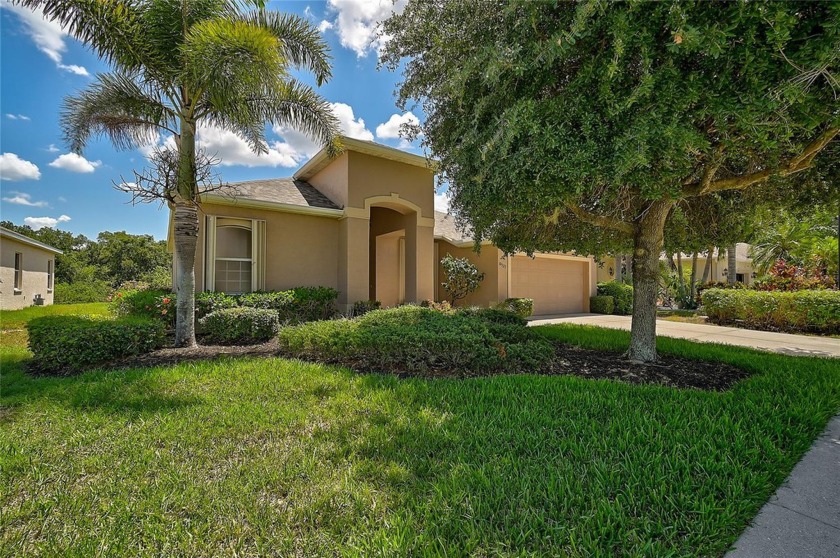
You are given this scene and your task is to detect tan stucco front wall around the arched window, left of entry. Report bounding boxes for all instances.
[195,204,341,290]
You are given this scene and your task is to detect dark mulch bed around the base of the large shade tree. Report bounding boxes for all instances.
[550,345,750,391]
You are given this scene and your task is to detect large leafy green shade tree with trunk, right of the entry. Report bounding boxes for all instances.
[382,0,840,361]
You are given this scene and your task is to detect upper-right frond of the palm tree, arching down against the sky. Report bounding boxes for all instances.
[240,10,332,86]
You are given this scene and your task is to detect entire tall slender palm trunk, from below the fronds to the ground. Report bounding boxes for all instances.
[174,118,198,347]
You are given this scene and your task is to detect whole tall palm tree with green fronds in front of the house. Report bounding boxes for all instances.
[14,0,341,347]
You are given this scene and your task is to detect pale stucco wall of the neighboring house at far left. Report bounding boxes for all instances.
[0,237,55,310]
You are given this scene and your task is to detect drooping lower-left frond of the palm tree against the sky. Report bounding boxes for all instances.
[61,72,178,153]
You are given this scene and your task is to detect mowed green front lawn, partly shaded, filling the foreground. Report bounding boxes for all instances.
[0,320,840,557]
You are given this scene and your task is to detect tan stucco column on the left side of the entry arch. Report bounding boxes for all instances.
[338,217,370,311]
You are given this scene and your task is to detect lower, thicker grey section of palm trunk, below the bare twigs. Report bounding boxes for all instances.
[174,202,198,347]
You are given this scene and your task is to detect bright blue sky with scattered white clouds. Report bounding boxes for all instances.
[0,0,442,238]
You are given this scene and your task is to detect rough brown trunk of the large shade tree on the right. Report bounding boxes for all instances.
[627,200,674,362]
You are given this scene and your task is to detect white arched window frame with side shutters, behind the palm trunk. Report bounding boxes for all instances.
[204,215,266,292]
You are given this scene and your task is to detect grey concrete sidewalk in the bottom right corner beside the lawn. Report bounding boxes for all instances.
[726,415,840,558]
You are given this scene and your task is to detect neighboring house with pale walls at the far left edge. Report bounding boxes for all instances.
[0,227,62,316]
